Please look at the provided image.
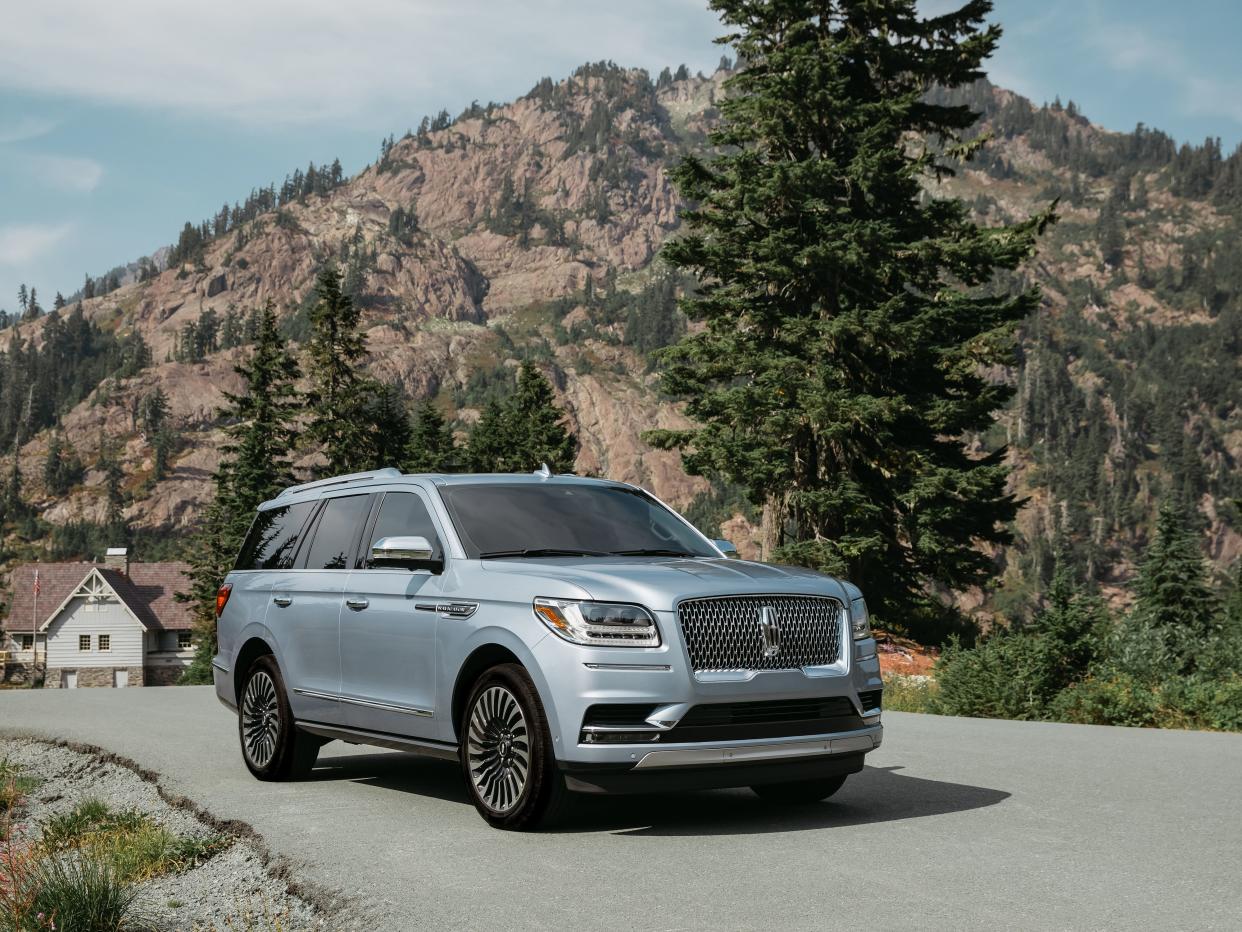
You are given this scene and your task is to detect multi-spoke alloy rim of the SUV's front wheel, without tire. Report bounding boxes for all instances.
[466,686,530,814]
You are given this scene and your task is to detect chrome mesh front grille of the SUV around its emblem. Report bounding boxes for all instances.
[677,595,842,672]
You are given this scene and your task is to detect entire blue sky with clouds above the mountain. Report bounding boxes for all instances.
[0,0,1242,311]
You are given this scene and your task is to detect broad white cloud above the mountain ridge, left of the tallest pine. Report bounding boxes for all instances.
[0,0,720,123]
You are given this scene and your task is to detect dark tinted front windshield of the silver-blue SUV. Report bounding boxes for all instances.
[440,482,720,559]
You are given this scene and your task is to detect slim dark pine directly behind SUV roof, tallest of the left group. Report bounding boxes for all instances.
[306,266,376,476]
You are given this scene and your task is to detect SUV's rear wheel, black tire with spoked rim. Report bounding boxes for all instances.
[237,655,323,780]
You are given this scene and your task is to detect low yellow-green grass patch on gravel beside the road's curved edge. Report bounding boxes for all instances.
[40,799,231,882]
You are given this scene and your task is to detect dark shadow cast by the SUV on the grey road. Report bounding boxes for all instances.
[309,752,1010,835]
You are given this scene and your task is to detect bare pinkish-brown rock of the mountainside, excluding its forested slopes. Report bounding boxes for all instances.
[7,66,1242,621]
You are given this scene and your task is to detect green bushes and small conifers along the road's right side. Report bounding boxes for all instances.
[929,505,1242,731]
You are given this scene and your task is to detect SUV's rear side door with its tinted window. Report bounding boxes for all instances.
[267,493,371,723]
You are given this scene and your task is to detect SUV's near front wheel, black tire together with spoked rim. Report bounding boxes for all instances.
[458,664,570,831]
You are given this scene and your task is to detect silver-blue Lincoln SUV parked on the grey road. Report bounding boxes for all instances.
[212,470,883,829]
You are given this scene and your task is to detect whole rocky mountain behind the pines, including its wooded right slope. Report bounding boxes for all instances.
[0,63,1242,623]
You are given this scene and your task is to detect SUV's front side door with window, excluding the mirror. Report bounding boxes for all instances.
[340,490,443,737]
